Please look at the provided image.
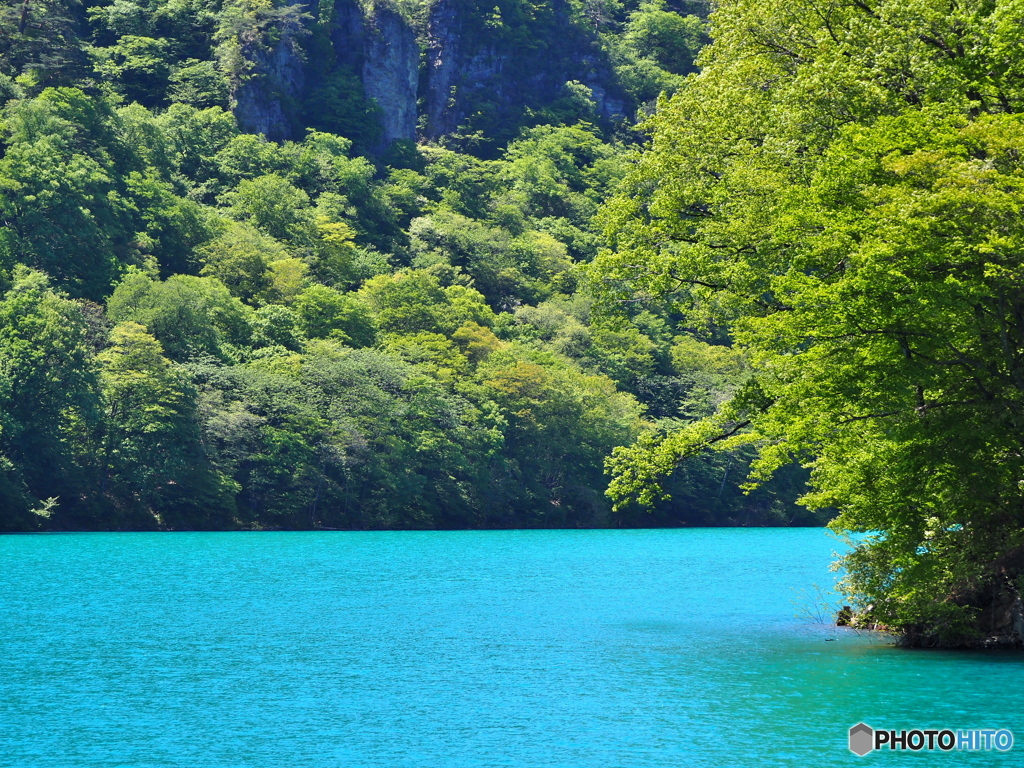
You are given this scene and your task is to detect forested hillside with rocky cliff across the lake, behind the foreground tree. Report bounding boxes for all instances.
[0,0,816,530]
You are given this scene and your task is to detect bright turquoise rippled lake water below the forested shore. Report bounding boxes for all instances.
[0,528,1024,768]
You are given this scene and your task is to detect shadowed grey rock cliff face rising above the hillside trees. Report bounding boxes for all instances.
[233,0,629,150]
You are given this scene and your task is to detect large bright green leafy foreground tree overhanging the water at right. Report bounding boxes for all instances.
[593,0,1024,644]
